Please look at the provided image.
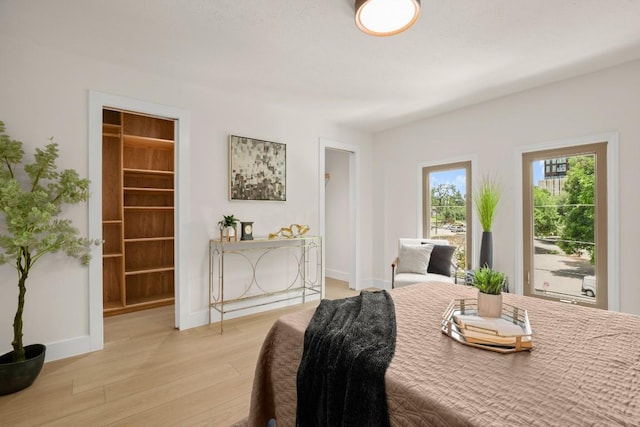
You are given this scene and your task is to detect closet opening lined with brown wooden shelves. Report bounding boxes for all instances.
[102,108,175,317]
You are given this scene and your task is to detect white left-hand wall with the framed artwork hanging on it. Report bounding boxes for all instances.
[0,30,372,357]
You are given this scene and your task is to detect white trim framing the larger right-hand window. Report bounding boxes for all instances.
[514,132,620,311]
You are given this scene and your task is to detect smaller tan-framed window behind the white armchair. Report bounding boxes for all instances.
[422,161,472,277]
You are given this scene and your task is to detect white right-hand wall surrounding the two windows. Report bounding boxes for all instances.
[373,61,640,314]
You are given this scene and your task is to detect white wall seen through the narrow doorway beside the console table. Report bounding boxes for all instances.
[324,149,351,281]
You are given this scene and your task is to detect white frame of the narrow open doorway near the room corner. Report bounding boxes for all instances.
[318,138,364,292]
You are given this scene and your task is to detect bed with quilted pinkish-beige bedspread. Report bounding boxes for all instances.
[241,283,640,427]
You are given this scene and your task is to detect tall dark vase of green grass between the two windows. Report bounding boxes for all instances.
[473,176,502,268]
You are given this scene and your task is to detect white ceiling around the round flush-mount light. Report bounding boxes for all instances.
[0,0,640,131]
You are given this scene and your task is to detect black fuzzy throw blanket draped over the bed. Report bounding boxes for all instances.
[296,291,396,427]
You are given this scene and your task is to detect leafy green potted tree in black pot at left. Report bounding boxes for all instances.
[0,121,100,395]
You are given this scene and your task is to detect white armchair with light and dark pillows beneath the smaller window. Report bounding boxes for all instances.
[391,238,458,288]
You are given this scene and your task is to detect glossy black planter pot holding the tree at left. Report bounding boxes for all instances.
[0,344,47,396]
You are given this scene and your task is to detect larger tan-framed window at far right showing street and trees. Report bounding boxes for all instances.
[522,142,608,309]
